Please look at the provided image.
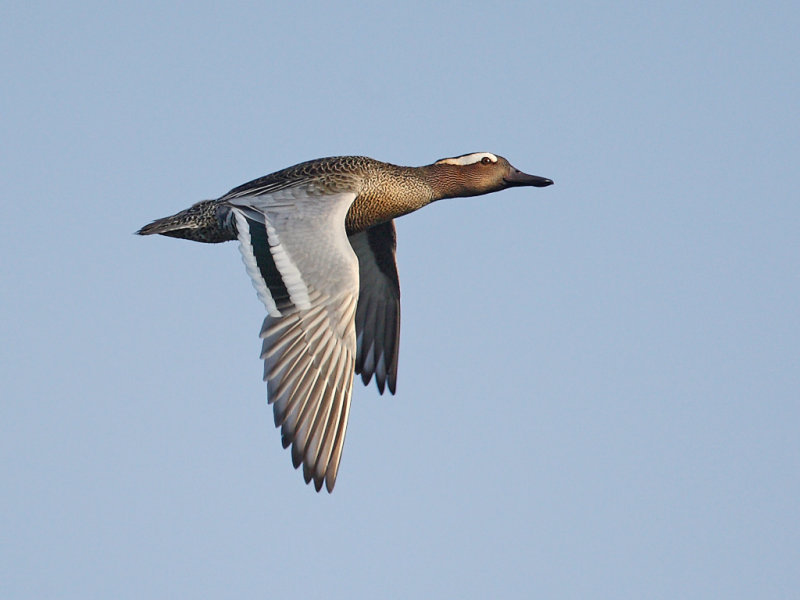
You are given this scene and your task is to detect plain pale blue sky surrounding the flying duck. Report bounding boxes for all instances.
[0,1,800,600]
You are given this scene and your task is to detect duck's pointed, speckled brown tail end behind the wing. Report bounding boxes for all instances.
[136,200,236,244]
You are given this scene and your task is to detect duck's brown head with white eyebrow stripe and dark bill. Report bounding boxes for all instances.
[422,152,553,200]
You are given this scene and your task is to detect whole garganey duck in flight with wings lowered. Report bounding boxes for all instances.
[138,152,553,492]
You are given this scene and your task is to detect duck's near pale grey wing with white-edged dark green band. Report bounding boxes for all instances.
[223,186,359,491]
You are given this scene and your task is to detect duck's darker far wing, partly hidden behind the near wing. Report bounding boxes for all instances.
[349,221,400,394]
